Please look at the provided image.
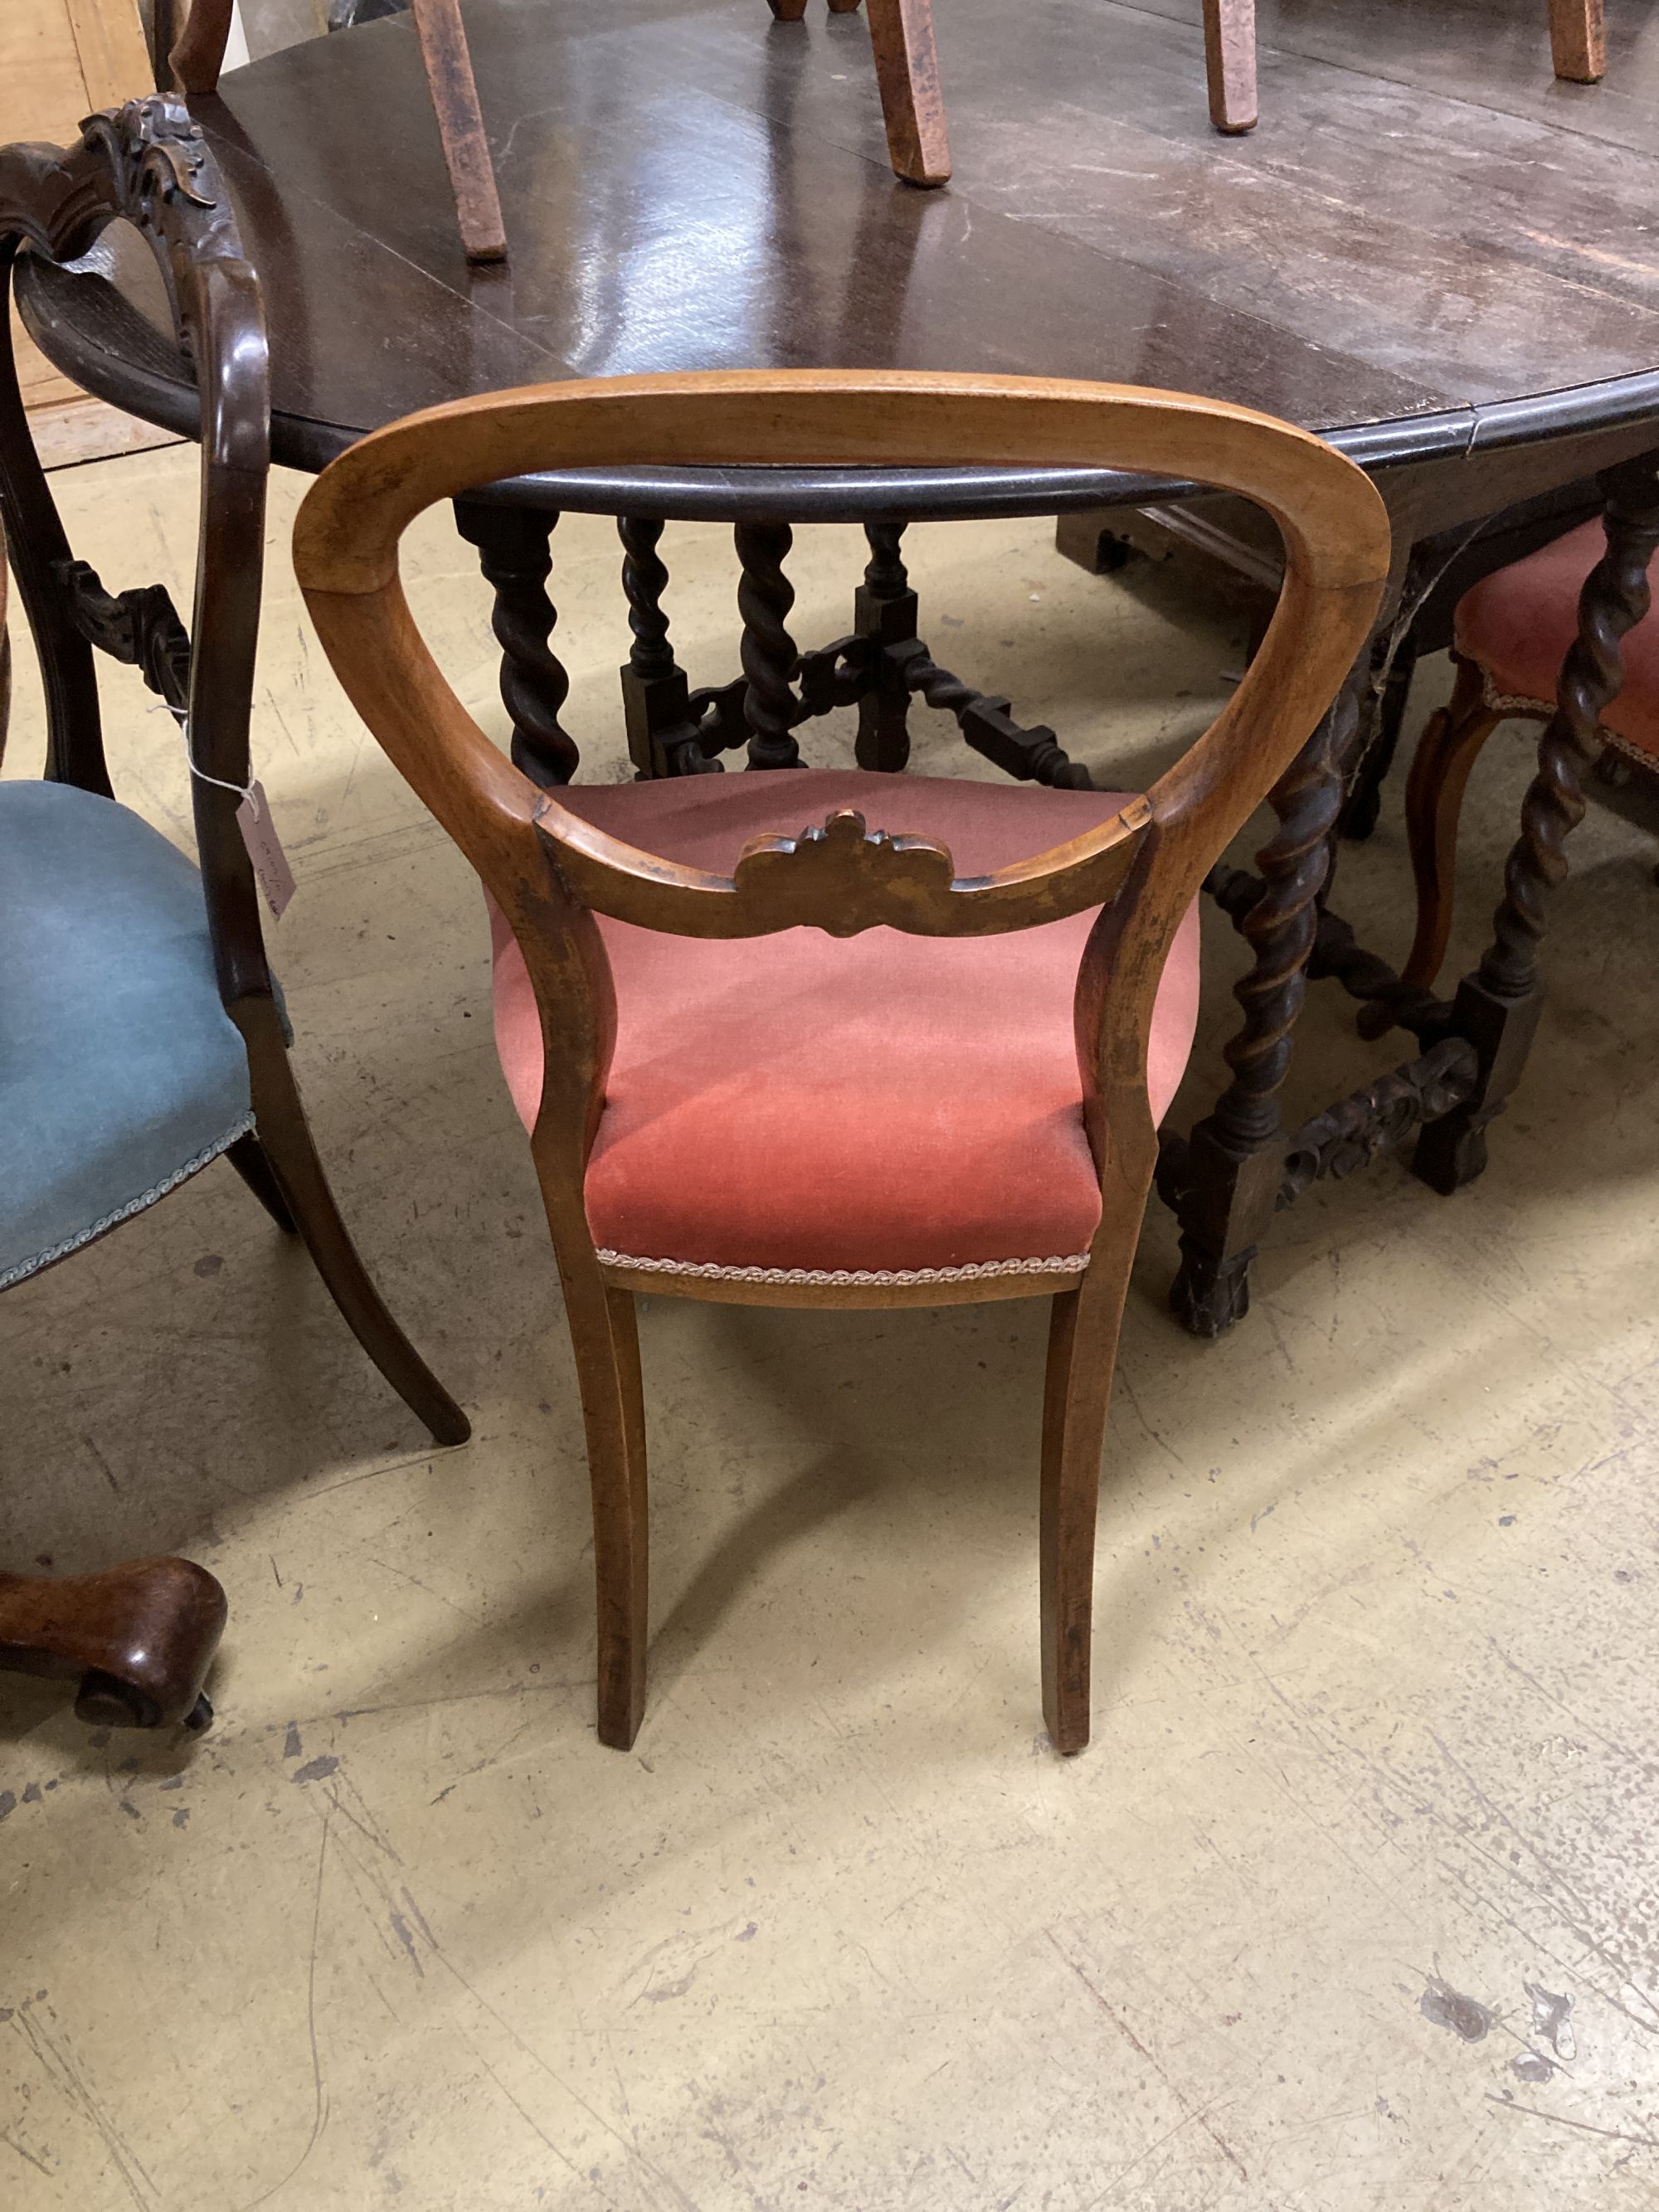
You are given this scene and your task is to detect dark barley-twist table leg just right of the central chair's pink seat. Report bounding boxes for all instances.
[1159,654,1370,1336]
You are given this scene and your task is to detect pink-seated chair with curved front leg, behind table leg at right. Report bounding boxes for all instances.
[1403,520,1659,986]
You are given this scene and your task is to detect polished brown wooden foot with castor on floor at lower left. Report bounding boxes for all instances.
[0,1559,226,1730]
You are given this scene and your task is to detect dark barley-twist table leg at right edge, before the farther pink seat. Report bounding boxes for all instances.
[1411,454,1659,1194]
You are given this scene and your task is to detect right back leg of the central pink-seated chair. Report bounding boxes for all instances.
[1039,1247,1151,1757]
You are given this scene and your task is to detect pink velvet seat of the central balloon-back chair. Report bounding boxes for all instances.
[494,770,1199,1270]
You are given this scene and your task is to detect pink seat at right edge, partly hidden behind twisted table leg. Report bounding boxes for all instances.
[1456,522,1659,754]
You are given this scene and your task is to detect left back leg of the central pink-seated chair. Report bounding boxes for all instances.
[564,1274,650,1752]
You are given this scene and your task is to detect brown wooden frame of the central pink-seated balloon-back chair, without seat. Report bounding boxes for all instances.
[294,372,1389,1752]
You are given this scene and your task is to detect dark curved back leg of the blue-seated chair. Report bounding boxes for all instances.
[243,1013,471,1445]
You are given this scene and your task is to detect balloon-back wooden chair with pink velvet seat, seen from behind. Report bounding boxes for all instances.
[294,372,1389,1752]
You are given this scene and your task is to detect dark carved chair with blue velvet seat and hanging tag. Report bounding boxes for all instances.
[0,97,467,1445]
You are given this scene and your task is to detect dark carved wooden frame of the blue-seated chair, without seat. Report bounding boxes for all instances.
[0,95,469,1445]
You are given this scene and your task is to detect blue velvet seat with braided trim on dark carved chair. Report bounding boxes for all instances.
[0,783,252,1290]
